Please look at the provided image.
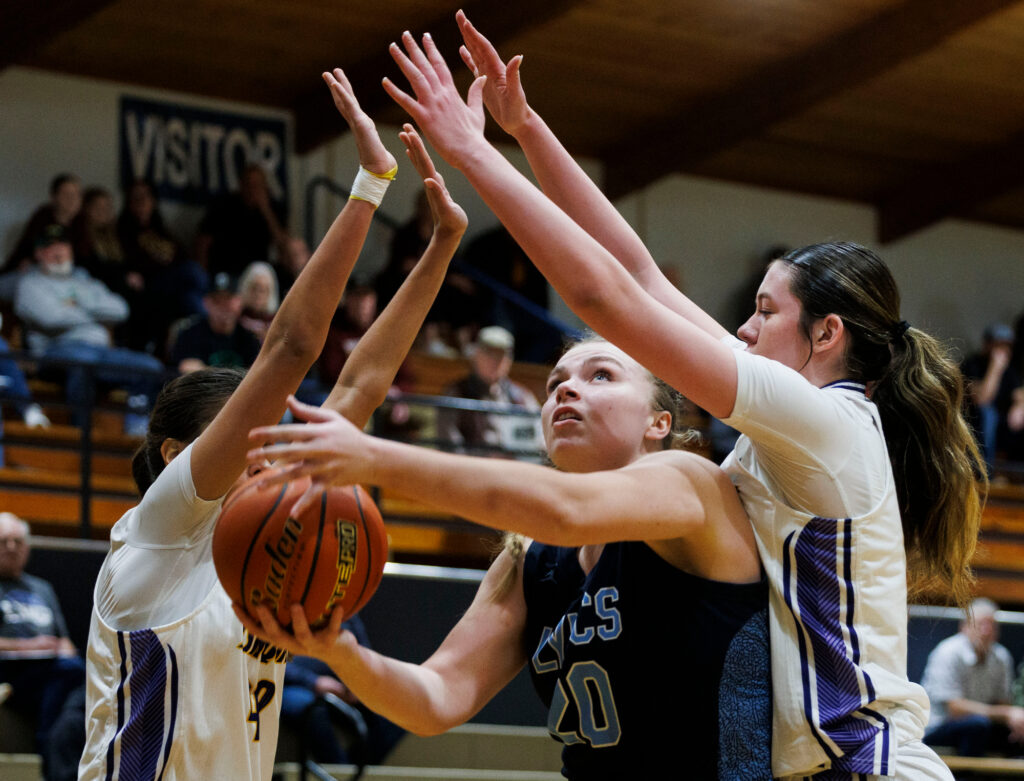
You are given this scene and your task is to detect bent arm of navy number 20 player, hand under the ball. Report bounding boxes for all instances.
[234,553,526,735]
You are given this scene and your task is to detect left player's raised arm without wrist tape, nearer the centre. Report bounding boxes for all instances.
[324,125,467,428]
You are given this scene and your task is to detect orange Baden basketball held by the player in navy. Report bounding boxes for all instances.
[213,471,387,628]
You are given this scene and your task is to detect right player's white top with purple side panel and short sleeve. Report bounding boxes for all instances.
[722,345,947,778]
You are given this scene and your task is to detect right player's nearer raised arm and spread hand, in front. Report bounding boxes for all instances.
[384,33,736,418]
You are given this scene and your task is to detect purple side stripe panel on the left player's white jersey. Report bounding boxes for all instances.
[108,630,176,781]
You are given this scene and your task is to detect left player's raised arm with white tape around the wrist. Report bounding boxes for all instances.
[191,69,395,498]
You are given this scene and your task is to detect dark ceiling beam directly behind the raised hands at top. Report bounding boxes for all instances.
[292,0,581,154]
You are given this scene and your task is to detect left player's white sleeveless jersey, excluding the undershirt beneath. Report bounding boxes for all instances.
[79,585,288,781]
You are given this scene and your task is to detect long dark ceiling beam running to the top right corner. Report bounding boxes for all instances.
[601,0,1019,198]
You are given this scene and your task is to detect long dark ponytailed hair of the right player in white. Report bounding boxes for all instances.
[780,243,985,604]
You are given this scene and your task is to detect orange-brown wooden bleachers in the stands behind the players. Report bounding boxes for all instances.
[6,353,1024,585]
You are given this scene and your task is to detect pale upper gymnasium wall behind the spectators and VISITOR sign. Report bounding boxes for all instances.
[0,68,1024,349]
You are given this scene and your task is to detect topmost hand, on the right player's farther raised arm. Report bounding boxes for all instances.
[455,10,530,136]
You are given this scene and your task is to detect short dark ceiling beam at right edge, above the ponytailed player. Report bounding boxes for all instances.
[876,130,1024,244]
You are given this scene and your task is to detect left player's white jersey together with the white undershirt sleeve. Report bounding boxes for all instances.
[79,448,288,781]
